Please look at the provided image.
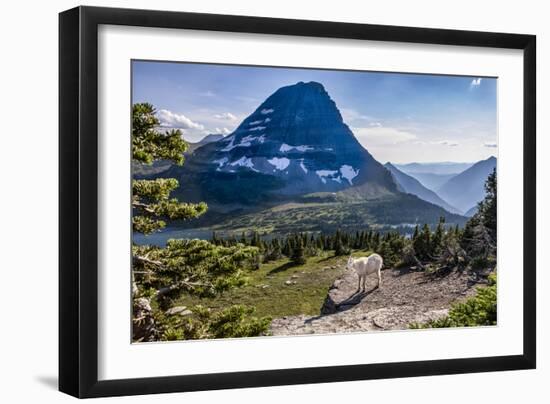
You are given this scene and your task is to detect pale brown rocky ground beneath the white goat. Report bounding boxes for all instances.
[271,268,484,335]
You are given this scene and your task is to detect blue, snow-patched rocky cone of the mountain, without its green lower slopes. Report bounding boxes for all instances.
[162,82,397,204]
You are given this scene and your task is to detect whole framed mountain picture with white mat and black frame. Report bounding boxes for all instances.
[59,7,536,397]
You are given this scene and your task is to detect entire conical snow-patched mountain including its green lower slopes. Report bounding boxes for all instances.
[134,82,466,234]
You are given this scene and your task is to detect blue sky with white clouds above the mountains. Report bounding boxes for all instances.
[132,61,497,163]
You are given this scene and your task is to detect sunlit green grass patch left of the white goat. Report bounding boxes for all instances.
[177,252,352,318]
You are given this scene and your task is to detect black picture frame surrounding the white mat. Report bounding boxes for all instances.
[59,7,536,398]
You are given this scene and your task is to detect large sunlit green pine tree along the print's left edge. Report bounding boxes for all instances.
[132,103,268,341]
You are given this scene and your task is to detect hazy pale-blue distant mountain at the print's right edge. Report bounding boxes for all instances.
[437,157,497,212]
